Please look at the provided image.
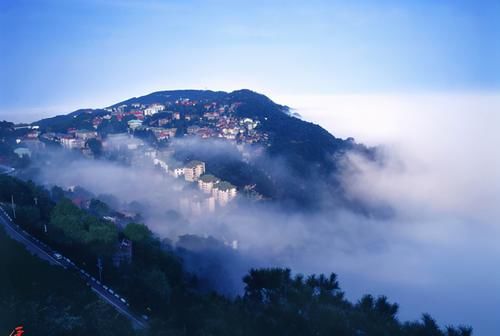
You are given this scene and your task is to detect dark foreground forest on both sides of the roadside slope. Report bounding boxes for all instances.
[0,176,472,336]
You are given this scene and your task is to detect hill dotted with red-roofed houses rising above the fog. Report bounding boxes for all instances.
[25,89,373,208]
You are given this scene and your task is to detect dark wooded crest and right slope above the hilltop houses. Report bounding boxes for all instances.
[34,89,369,176]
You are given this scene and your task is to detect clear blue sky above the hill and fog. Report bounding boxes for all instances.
[0,0,500,119]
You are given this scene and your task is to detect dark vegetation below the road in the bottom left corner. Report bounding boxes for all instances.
[0,228,136,336]
